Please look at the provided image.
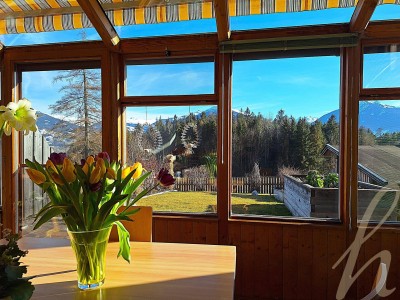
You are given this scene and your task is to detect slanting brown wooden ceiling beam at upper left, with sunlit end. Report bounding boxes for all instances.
[77,0,120,50]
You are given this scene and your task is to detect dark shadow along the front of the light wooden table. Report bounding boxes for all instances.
[32,270,238,300]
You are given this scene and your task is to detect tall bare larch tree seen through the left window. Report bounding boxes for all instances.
[49,69,102,160]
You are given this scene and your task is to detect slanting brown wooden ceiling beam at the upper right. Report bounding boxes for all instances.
[350,0,379,33]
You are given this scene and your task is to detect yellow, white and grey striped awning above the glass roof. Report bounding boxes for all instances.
[0,0,400,34]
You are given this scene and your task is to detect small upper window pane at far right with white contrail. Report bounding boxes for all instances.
[363,44,400,88]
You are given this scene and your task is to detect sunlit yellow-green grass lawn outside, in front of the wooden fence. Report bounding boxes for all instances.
[137,192,292,216]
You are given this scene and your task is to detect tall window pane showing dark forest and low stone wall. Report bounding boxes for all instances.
[231,56,340,218]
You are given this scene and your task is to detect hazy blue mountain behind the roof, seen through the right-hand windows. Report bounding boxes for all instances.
[319,101,400,132]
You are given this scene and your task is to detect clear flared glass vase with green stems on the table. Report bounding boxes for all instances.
[68,227,112,290]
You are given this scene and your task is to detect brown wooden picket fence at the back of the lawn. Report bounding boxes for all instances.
[174,176,283,194]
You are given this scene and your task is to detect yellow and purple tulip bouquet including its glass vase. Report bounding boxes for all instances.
[26,152,174,289]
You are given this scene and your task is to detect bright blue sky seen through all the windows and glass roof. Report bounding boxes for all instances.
[0,5,400,122]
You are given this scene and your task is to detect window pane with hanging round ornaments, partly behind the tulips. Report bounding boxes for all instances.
[126,106,217,213]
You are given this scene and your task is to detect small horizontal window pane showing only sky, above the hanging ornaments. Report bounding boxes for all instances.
[127,62,214,96]
